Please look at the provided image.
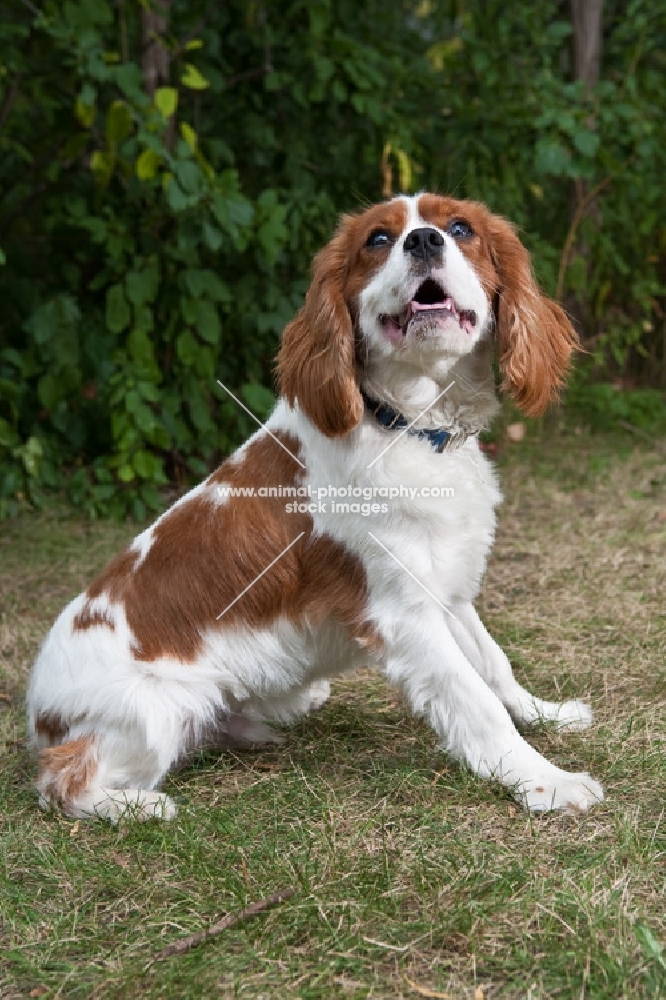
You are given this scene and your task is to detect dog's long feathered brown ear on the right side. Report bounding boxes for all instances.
[491,218,580,417]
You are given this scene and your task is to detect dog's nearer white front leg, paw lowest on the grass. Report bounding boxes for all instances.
[384,609,603,812]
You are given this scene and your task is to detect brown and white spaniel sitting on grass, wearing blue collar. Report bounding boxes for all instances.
[27,194,603,821]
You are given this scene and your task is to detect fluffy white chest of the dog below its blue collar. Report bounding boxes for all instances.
[304,433,501,602]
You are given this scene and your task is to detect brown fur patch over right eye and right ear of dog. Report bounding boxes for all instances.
[419,195,579,416]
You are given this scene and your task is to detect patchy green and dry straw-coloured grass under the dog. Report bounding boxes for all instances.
[0,428,666,1000]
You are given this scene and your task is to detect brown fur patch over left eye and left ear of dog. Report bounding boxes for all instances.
[277,201,406,437]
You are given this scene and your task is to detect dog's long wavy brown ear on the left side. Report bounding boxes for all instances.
[277,220,363,437]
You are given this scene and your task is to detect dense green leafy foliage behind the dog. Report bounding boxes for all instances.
[0,0,666,517]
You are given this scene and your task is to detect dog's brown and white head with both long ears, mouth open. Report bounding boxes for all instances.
[278,194,578,437]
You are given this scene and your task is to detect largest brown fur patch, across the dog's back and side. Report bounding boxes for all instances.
[79,433,380,662]
